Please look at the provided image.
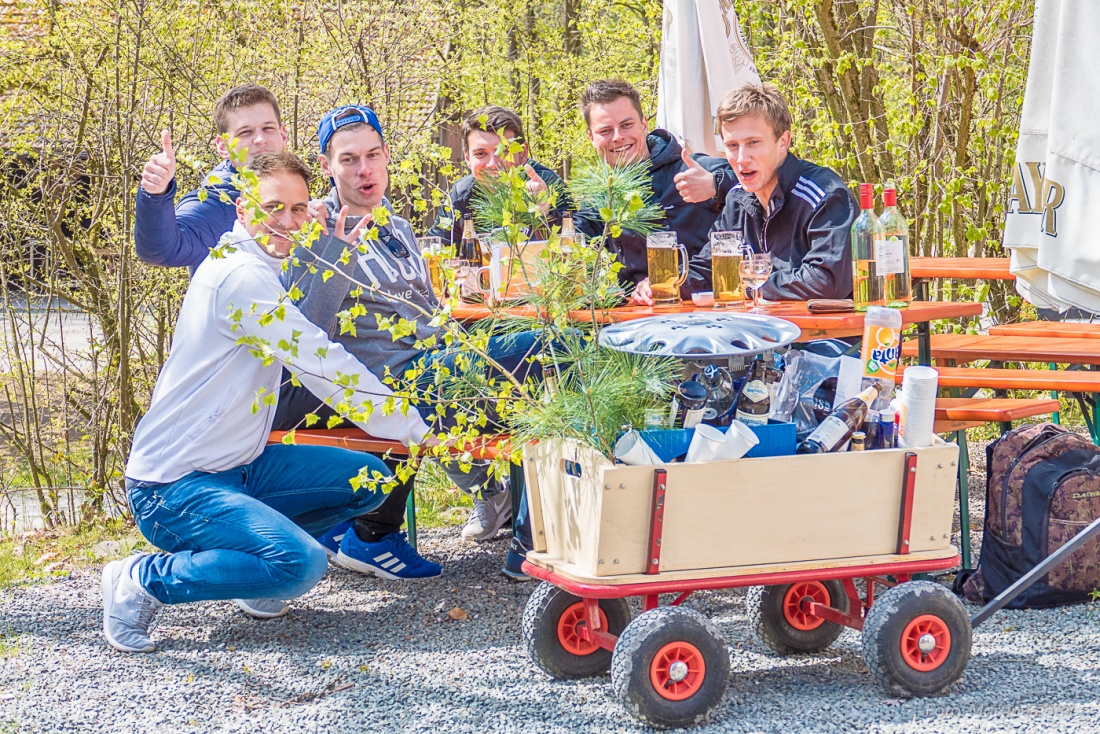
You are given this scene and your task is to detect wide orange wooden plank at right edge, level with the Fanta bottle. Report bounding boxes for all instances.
[901,333,1100,364]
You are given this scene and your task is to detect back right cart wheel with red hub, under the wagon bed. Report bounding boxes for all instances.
[745,579,849,655]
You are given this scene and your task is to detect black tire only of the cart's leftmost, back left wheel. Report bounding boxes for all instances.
[524,581,631,680]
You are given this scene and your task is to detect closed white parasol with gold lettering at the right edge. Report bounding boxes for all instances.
[1004,0,1100,313]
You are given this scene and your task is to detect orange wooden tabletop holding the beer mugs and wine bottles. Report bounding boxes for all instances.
[452,300,981,339]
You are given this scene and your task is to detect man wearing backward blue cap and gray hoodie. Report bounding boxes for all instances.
[275,105,540,577]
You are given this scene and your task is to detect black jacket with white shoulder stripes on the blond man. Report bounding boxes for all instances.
[689,153,859,300]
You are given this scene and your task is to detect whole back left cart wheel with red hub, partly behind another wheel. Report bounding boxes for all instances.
[524,582,631,680]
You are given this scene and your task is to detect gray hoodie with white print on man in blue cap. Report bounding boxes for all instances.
[283,188,440,385]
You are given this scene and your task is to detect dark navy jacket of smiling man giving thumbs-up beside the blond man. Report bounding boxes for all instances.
[574,129,737,298]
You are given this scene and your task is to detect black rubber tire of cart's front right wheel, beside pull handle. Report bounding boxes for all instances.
[864,581,971,698]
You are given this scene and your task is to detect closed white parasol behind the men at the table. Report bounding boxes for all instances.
[657,0,760,155]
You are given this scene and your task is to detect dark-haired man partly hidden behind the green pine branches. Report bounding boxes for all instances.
[428,106,572,244]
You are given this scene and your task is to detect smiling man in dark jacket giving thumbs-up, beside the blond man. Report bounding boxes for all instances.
[576,79,737,306]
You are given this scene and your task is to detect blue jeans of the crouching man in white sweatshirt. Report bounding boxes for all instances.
[127,445,391,604]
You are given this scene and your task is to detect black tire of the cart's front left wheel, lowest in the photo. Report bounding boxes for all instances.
[612,606,729,728]
